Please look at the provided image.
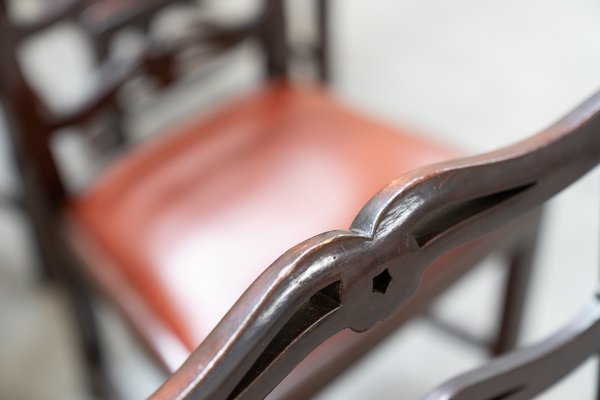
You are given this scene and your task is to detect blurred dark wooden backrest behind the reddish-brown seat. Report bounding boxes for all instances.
[0,0,328,208]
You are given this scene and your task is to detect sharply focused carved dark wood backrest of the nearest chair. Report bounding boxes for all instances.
[144,93,600,400]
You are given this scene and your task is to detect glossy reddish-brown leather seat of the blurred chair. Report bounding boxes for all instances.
[67,82,456,360]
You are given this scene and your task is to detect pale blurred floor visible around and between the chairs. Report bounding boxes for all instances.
[0,0,600,400]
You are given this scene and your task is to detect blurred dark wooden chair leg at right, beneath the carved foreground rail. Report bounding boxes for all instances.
[490,210,542,356]
